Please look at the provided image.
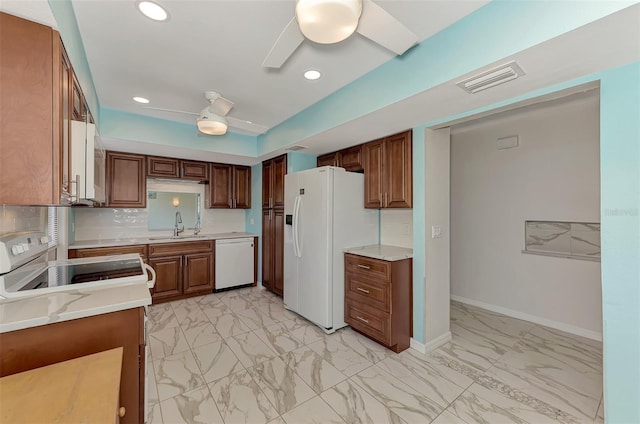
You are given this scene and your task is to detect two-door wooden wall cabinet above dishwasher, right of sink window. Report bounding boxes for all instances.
[207,163,251,209]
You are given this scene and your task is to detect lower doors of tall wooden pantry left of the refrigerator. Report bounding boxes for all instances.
[262,209,284,296]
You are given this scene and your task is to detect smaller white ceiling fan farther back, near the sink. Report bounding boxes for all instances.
[145,91,269,135]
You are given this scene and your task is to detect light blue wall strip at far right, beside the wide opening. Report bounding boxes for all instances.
[600,62,640,423]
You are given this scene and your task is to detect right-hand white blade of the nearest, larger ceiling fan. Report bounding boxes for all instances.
[356,0,419,55]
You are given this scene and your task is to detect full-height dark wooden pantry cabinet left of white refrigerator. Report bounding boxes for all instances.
[262,155,287,296]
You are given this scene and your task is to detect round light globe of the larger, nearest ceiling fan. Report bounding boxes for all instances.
[296,0,362,44]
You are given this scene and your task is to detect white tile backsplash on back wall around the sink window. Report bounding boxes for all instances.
[74,180,246,241]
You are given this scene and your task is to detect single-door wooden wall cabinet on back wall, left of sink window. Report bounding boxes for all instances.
[107,152,147,208]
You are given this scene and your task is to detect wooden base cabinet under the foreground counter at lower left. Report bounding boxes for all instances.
[0,307,145,424]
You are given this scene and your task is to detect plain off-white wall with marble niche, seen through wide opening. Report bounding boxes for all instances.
[448,92,602,338]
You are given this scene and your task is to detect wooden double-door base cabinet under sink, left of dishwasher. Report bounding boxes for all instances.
[148,240,215,303]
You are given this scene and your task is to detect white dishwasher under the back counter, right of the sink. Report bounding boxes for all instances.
[215,237,255,291]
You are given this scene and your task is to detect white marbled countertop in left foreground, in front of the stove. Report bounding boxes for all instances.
[0,281,151,333]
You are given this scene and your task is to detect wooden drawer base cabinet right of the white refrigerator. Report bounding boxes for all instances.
[344,253,413,352]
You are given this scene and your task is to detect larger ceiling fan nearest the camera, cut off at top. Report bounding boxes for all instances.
[262,0,418,68]
